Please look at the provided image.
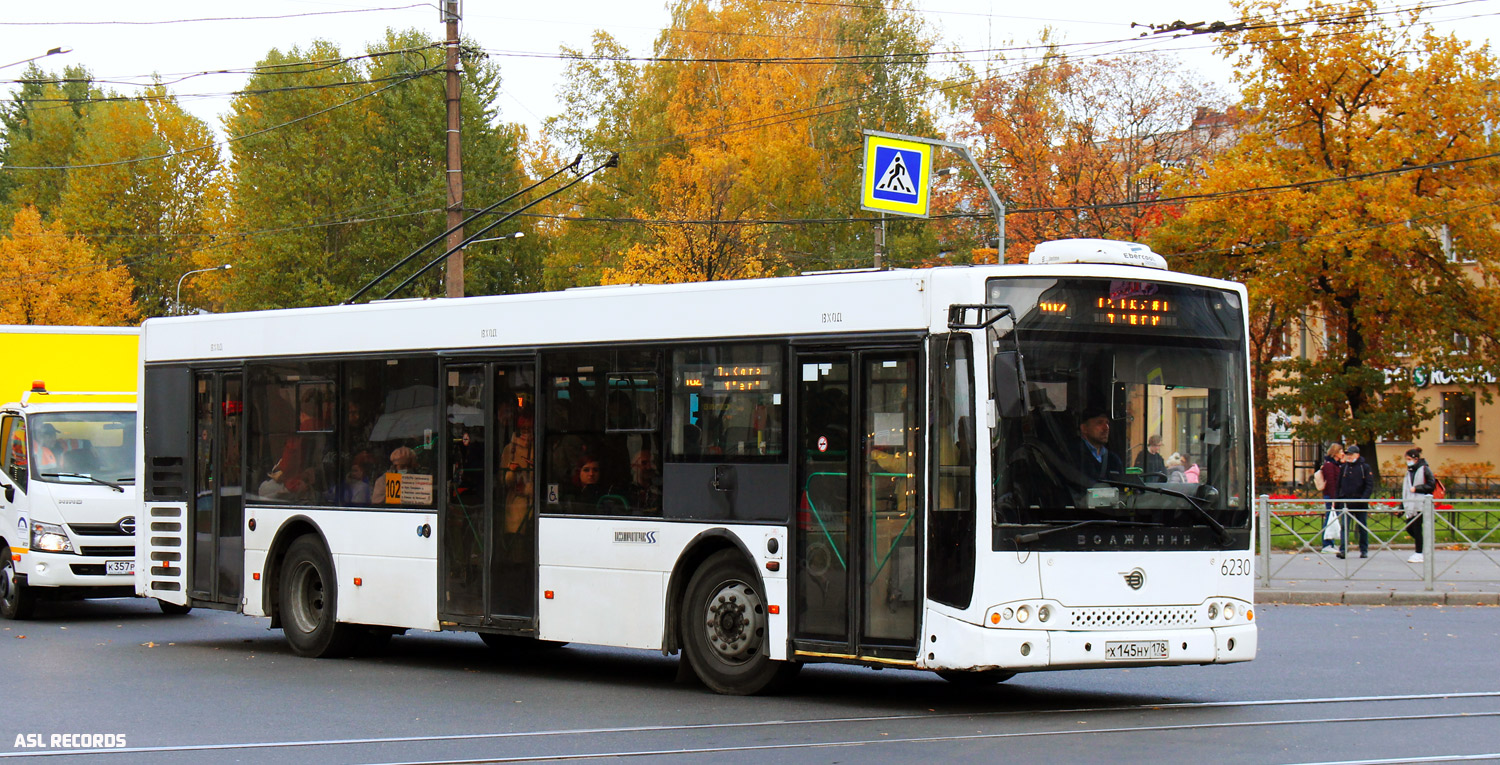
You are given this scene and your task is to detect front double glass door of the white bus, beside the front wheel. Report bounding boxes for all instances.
[792,348,924,662]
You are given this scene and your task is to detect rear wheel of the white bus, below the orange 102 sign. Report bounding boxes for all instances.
[278,534,359,659]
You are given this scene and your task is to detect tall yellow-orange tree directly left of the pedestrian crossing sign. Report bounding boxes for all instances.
[549,0,936,284]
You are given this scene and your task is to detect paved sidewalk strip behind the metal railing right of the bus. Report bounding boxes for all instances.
[1256,548,1500,606]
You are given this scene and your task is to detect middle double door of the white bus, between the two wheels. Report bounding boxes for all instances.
[438,362,537,633]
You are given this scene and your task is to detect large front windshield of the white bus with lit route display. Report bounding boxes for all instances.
[990,279,1250,551]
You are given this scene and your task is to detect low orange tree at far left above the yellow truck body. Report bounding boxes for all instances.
[0,206,140,327]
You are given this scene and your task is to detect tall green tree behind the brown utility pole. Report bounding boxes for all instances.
[224,32,540,309]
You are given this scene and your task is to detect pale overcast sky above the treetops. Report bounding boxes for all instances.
[0,0,1500,141]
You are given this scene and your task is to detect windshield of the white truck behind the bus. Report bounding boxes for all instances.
[30,411,135,483]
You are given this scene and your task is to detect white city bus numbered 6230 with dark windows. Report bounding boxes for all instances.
[137,240,1256,693]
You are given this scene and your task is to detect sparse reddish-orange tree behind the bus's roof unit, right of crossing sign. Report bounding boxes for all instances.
[957,47,1224,261]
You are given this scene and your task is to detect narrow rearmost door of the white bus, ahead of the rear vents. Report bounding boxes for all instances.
[188,371,245,606]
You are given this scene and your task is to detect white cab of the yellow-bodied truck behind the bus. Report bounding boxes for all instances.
[0,384,137,620]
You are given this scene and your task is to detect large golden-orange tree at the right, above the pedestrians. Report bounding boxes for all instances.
[1154,0,1500,477]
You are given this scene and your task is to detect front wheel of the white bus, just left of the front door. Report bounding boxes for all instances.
[683,551,803,696]
